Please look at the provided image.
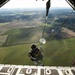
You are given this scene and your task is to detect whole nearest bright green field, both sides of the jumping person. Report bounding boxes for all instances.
[0,38,75,66]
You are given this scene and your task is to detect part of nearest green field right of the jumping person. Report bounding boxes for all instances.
[44,38,75,66]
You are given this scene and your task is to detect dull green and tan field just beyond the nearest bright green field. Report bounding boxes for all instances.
[3,27,42,45]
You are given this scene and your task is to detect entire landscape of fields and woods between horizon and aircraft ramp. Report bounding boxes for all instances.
[0,9,75,66]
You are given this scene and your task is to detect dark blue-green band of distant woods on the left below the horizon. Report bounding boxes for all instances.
[0,15,34,23]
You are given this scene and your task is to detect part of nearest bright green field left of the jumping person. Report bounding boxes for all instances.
[0,45,31,65]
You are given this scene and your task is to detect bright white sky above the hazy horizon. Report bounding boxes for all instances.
[2,0,70,8]
